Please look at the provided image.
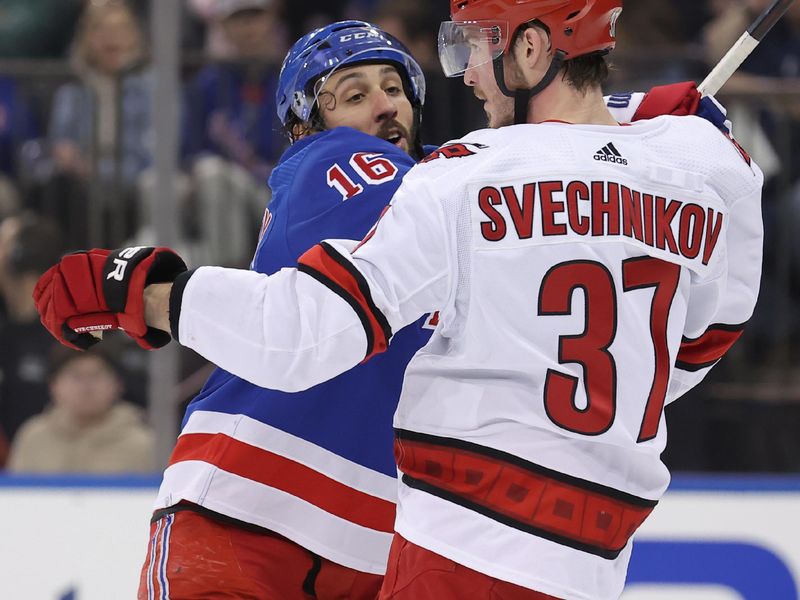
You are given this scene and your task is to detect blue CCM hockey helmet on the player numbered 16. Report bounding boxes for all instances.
[275,21,425,125]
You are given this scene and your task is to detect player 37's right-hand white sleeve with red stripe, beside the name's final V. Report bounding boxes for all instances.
[668,163,764,401]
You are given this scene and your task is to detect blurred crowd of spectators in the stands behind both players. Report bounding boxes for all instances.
[0,0,800,473]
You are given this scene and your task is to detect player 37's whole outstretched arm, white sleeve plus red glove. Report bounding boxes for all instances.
[34,171,446,391]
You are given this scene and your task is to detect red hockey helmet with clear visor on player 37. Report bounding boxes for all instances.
[439,0,622,77]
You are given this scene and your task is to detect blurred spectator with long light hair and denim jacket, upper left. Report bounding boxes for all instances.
[44,2,152,247]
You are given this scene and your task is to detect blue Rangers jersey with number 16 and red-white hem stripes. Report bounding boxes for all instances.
[156,128,433,574]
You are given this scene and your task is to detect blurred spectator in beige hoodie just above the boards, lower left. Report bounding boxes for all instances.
[8,346,155,473]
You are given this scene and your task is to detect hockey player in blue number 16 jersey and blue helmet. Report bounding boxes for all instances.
[134,21,431,600]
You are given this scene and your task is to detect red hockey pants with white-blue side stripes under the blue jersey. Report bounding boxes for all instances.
[138,510,383,600]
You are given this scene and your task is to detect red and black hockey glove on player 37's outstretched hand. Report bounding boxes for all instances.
[33,246,186,350]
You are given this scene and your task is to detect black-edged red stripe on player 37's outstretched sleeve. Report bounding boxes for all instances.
[297,242,392,362]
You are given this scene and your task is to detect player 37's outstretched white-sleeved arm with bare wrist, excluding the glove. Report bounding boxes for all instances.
[151,171,451,391]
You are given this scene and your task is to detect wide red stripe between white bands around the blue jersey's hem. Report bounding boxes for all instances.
[169,433,395,533]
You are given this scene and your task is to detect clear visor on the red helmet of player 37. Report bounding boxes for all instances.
[439,21,508,77]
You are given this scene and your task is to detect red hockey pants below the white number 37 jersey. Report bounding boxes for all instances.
[378,534,556,600]
